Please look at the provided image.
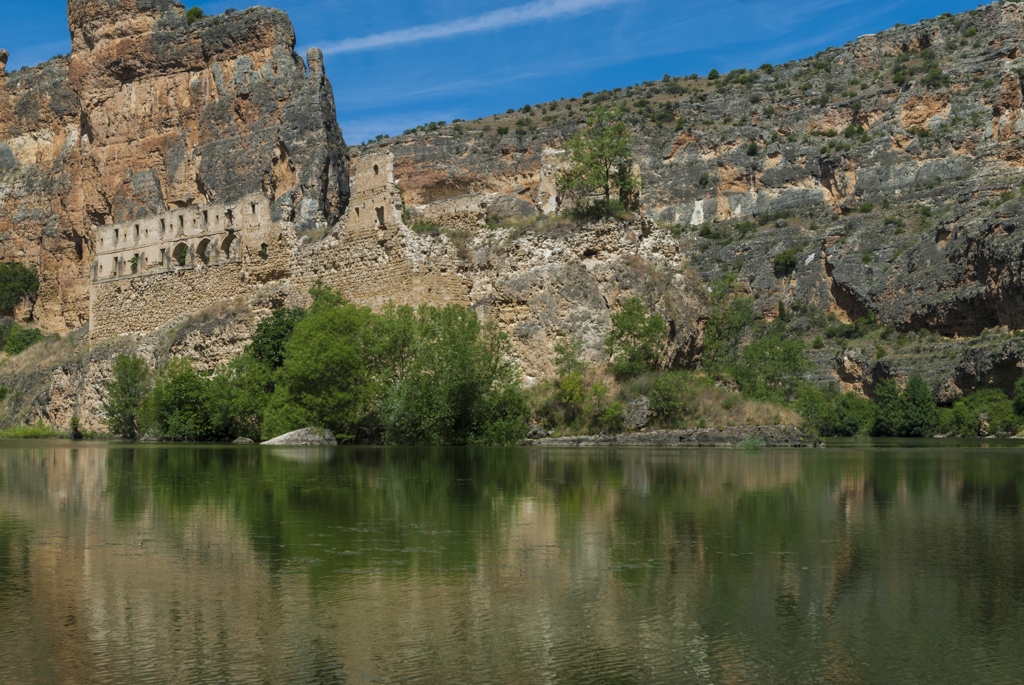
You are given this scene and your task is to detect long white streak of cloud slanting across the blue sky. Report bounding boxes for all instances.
[324,0,629,54]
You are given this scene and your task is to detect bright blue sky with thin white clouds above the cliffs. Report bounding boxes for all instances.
[0,0,980,144]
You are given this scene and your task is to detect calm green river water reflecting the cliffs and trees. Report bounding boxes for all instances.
[0,440,1024,685]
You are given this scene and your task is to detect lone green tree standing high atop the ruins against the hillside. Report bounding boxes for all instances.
[557,106,640,217]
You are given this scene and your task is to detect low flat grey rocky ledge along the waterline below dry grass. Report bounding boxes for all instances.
[522,426,824,447]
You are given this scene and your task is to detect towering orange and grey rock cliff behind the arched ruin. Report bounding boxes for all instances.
[0,0,348,332]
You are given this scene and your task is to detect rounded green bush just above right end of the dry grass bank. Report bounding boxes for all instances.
[732,333,811,400]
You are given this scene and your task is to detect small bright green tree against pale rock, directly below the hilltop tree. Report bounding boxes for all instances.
[604,297,669,377]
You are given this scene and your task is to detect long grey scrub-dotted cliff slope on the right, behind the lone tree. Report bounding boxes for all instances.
[369,2,1024,394]
